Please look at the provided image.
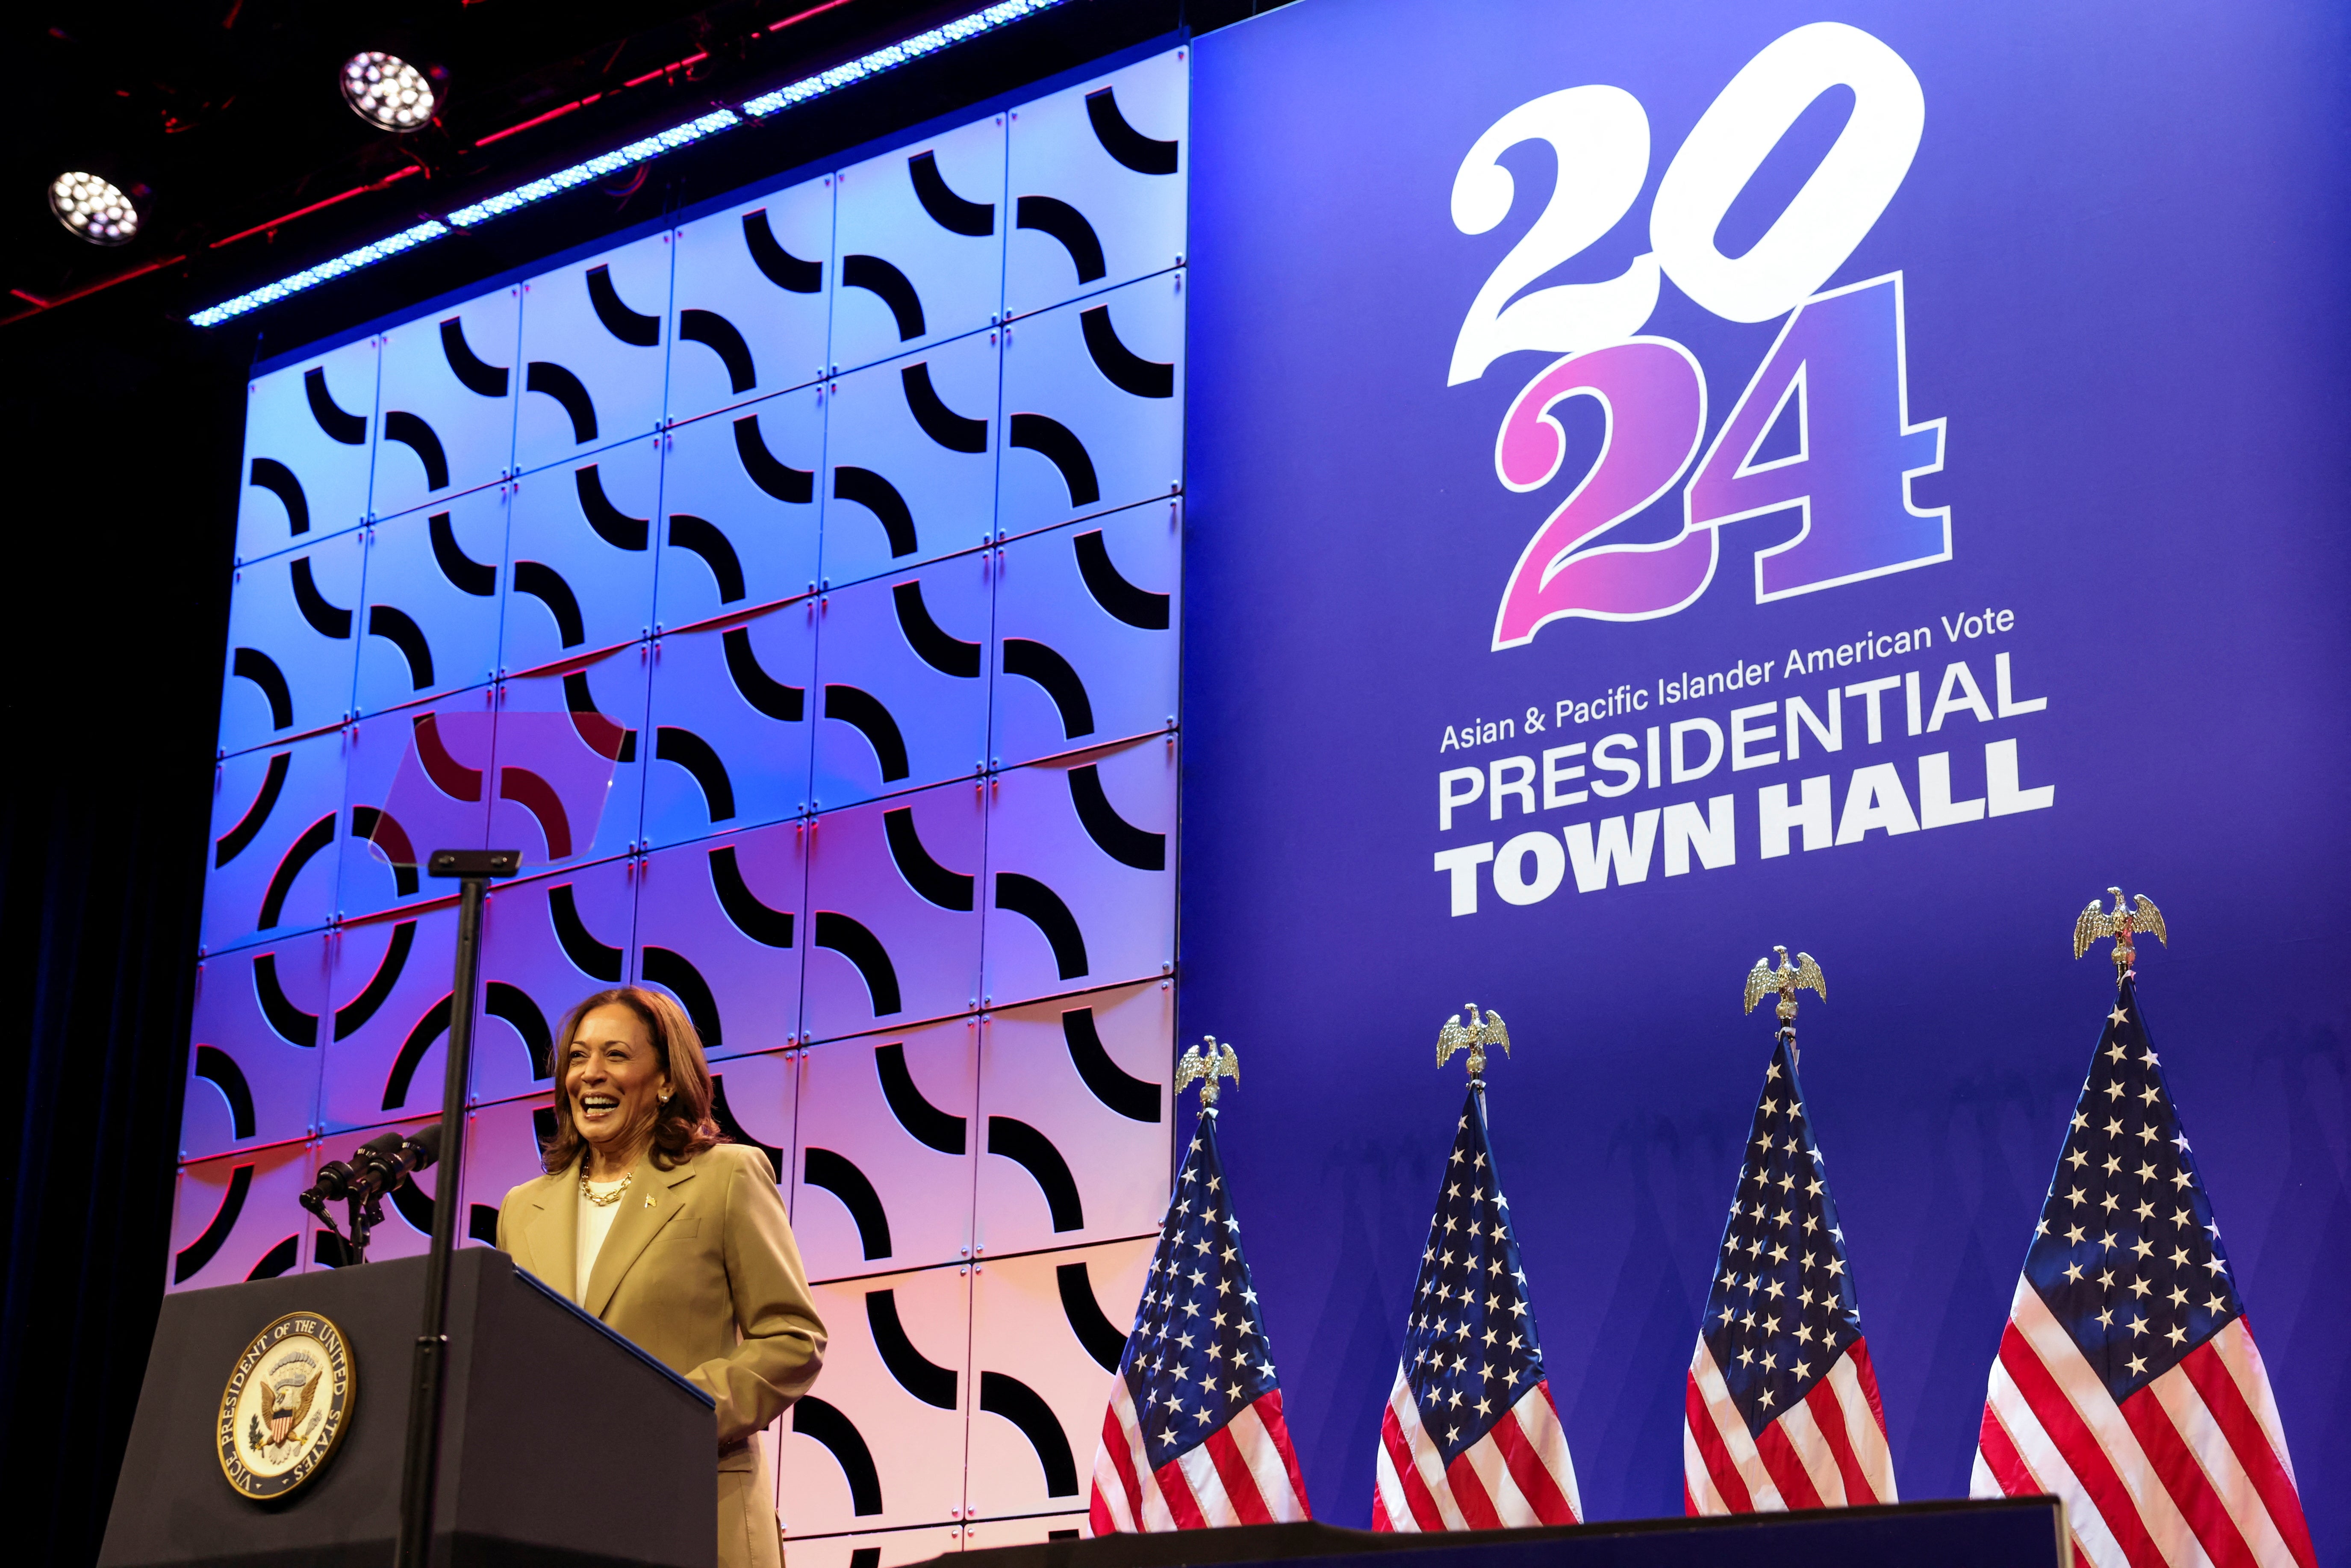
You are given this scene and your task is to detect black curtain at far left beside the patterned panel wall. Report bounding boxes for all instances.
[0,297,252,1563]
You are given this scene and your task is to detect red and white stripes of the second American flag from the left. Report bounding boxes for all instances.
[1371,1366,1585,1530]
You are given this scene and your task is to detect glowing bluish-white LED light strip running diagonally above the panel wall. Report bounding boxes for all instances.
[188,0,1063,327]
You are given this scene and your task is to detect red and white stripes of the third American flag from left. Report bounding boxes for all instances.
[1681,1338,1897,1516]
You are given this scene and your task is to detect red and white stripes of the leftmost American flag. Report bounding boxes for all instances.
[1089,1378,1312,1535]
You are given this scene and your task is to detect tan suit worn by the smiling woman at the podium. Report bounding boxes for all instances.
[498,1143,825,1568]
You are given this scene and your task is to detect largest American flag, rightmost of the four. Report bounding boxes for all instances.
[1970,973,2316,1568]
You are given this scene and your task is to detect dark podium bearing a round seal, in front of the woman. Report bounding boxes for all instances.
[99,1246,717,1568]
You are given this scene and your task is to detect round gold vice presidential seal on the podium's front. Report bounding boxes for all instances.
[214,1312,353,1502]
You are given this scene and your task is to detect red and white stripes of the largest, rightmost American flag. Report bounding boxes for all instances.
[1970,1279,2318,1568]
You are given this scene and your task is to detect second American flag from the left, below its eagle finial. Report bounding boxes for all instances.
[1371,1086,1582,1530]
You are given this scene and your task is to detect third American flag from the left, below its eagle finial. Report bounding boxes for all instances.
[1681,1035,1895,1514]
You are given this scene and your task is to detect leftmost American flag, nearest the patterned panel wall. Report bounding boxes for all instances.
[1089,1110,1310,1535]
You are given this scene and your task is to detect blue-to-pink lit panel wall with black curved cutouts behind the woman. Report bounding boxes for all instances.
[167,49,1190,1568]
